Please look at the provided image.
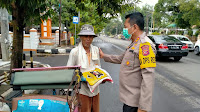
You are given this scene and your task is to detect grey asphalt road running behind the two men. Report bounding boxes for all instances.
[27,38,200,112]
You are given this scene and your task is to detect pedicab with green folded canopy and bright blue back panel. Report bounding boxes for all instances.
[11,66,82,112]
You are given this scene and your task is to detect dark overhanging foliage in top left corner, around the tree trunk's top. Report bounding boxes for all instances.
[0,0,53,26]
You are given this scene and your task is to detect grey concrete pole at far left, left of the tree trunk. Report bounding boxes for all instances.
[0,8,9,61]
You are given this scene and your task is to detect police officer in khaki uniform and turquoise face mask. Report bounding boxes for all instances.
[100,12,156,112]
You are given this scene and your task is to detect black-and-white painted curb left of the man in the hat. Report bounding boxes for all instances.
[37,49,71,54]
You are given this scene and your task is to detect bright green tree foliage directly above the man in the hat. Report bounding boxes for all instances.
[51,0,131,36]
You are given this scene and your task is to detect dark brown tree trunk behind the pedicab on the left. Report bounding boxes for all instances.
[11,3,24,69]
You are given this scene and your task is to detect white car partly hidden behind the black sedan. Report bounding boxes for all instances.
[169,35,194,51]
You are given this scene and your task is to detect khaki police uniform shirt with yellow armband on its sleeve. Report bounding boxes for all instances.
[103,33,156,111]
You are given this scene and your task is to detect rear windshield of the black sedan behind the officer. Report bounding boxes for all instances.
[154,36,180,43]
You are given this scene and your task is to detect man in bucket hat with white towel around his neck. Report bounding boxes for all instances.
[67,24,100,112]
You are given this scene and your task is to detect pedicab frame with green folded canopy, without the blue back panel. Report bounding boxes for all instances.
[11,66,82,112]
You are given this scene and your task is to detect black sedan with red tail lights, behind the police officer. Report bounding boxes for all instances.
[148,35,189,61]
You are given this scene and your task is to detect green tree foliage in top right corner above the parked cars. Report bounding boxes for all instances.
[154,0,200,28]
